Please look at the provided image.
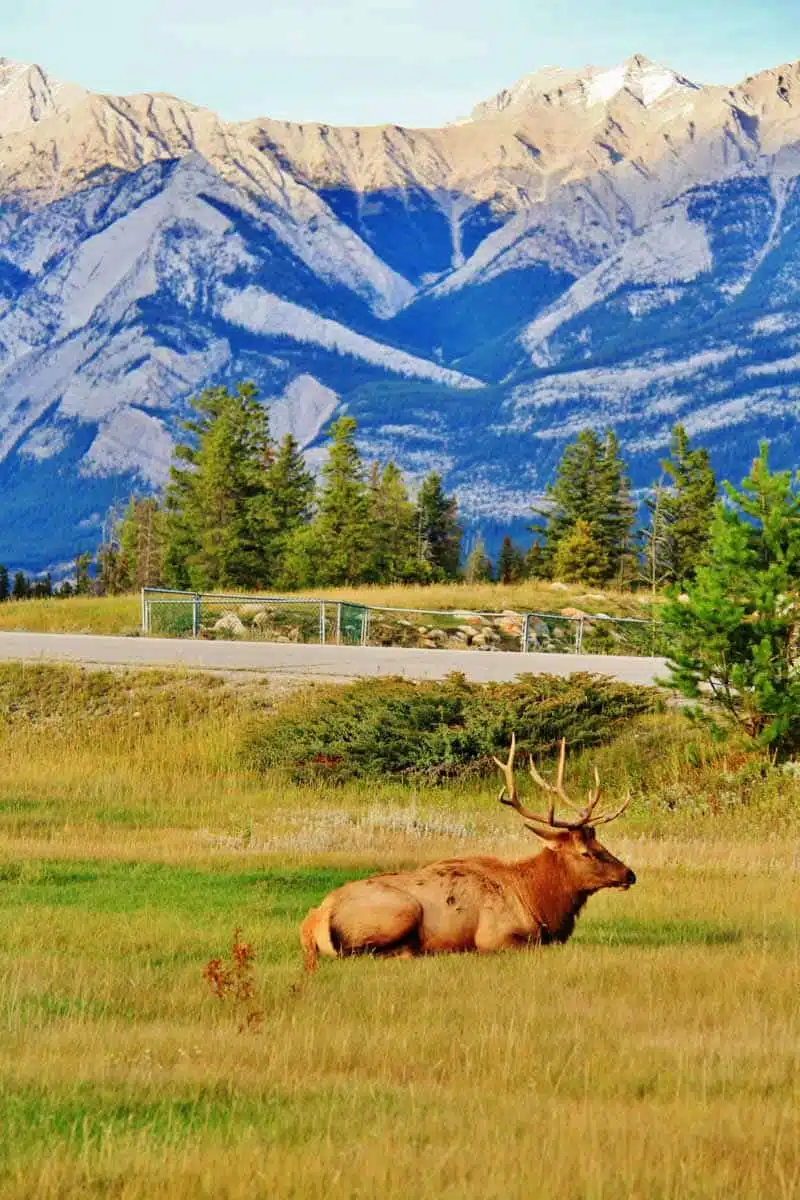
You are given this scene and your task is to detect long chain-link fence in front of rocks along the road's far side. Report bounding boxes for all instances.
[142,588,664,656]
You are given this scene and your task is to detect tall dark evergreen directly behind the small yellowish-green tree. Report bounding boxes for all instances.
[534,430,634,583]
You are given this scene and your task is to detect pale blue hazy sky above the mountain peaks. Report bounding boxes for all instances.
[6,0,800,125]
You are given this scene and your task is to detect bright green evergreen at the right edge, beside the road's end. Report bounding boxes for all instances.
[662,443,800,757]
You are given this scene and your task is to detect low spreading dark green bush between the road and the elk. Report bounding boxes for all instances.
[245,674,658,780]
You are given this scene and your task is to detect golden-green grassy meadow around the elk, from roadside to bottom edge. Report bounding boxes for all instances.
[0,666,800,1200]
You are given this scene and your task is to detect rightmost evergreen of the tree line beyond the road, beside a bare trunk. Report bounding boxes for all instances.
[648,425,717,582]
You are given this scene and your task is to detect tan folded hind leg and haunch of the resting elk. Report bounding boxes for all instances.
[331,881,422,955]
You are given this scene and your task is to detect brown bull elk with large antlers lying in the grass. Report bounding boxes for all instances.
[300,736,636,971]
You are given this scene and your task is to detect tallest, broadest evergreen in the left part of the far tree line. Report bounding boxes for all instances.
[164,383,278,590]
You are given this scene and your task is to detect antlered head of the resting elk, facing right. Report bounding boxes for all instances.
[494,734,636,895]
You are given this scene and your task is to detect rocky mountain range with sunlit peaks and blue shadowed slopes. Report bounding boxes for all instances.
[0,55,800,571]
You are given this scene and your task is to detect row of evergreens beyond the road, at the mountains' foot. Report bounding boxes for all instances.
[0,383,717,600]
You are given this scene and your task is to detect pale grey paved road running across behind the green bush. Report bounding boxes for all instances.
[0,634,666,684]
